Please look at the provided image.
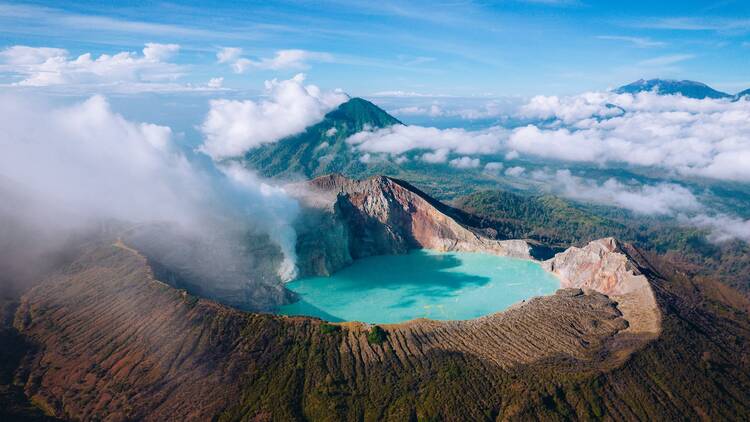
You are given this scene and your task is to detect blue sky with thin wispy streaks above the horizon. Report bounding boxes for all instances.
[0,0,750,97]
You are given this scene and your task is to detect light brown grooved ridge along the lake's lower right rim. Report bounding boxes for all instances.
[340,289,628,368]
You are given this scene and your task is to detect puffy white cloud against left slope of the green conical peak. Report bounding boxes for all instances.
[200,74,348,160]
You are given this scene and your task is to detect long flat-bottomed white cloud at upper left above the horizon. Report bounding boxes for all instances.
[0,43,208,92]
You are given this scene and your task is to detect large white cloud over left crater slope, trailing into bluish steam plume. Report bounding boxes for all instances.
[0,91,298,294]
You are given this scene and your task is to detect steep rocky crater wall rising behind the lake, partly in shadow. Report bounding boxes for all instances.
[289,174,533,274]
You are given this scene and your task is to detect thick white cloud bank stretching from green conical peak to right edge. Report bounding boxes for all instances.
[349,92,750,182]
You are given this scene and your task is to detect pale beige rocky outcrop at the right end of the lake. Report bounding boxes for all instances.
[543,238,661,336]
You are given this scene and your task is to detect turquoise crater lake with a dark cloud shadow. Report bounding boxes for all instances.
[278,249,560,324]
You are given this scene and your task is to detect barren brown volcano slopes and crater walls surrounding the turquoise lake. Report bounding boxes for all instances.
[4,176,750,421]
